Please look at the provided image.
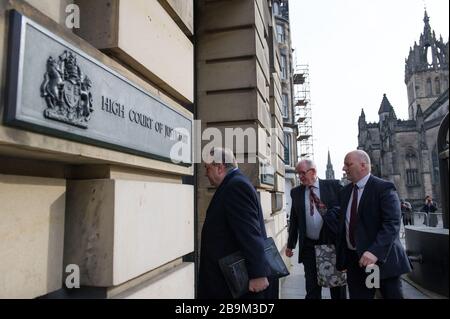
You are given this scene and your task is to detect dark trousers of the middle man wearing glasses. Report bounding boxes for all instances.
[302,238,347,299]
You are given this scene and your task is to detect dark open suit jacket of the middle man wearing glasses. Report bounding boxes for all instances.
[287,179,342,263]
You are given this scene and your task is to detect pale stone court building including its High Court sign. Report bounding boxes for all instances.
[0,0,296,299]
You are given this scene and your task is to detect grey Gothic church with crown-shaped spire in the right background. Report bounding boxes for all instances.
[358,12,449,208]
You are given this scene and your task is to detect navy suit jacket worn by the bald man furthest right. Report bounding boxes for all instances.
[336,176,411,279]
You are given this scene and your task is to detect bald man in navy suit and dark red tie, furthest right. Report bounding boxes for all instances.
[336,151,411,299]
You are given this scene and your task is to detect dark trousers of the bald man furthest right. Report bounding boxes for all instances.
[346,249,403,299]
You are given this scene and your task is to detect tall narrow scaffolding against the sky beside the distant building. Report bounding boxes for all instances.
[293,64,314,160]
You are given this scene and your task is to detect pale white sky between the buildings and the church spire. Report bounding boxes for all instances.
[289,0,449,179]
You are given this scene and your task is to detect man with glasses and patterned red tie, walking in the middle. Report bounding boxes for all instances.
[286,160,346,299]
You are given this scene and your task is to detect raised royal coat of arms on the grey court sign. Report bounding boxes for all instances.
[41,51,94,129]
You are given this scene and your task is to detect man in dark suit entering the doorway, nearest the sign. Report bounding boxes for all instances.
[198,148,269,299]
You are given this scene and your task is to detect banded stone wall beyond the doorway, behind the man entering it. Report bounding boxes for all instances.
[196,0,287,296]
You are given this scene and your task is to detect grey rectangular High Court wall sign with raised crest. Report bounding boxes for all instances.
[5,11,192,165]
